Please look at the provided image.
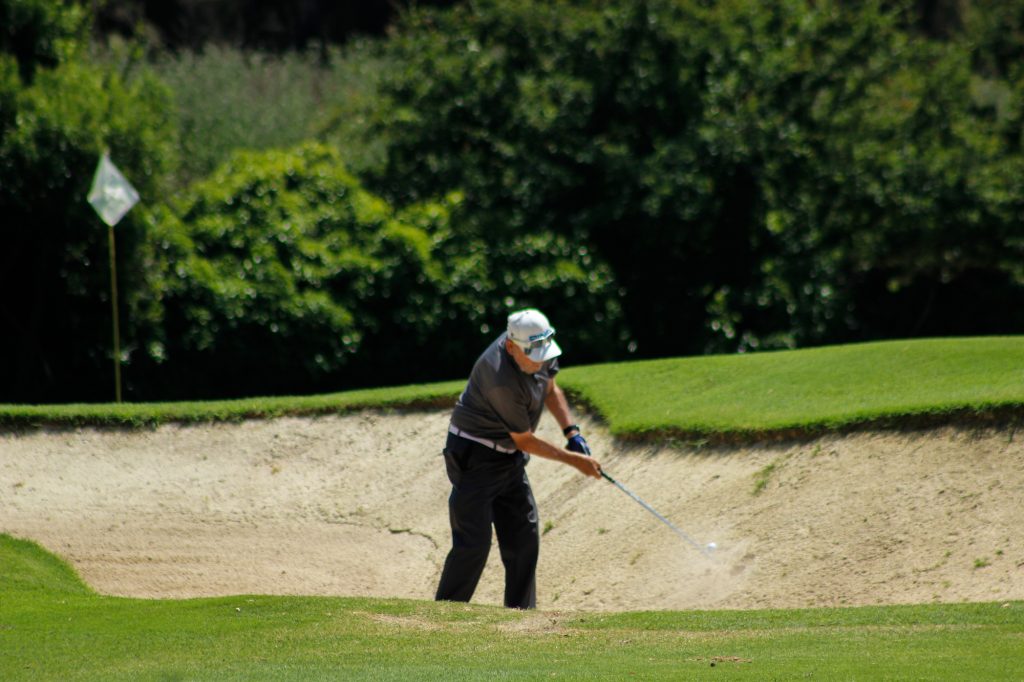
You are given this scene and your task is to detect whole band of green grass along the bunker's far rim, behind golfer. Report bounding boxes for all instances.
[0,337,1024,439]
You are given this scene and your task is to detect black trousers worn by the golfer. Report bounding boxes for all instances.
[436,433,541,608]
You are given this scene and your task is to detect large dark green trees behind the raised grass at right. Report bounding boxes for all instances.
[377,0,1024,356]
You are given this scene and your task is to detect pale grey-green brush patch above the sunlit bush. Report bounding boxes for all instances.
[148,41,388,188]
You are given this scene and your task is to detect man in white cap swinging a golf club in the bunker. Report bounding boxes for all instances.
[436,308,601,608]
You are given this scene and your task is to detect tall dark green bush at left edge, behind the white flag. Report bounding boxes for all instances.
[0,0,174,401]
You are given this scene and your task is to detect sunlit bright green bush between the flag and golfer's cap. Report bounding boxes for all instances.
[132,145,616,397]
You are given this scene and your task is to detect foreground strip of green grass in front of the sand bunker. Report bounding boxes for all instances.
[0,536,1024,680]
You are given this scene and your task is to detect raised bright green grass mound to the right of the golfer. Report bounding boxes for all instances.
[560,337,1024,437]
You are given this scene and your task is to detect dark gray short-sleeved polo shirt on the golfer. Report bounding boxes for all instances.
[452,334,558,449]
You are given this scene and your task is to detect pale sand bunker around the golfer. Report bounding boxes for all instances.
[0,405,1024,610]
